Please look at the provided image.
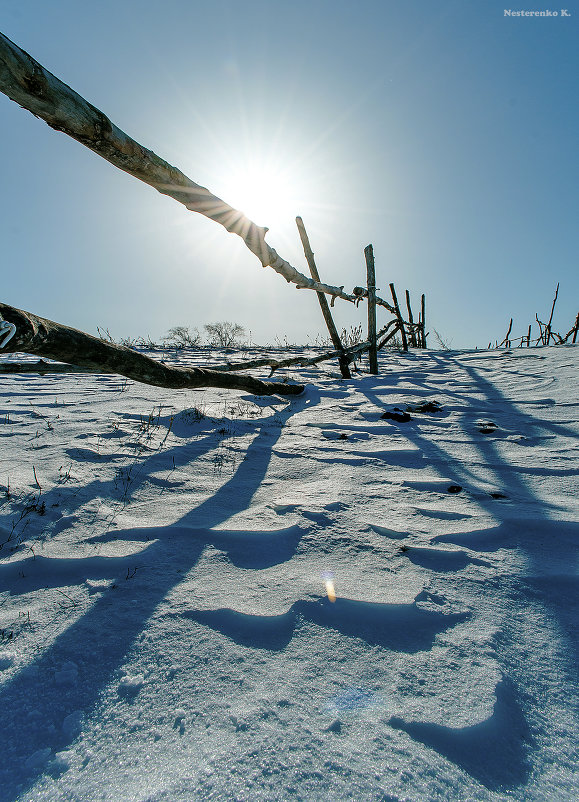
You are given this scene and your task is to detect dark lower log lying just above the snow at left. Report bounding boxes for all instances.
[0,303,304,395]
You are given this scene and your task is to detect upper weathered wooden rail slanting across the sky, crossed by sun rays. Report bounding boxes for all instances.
[0,34,356,302]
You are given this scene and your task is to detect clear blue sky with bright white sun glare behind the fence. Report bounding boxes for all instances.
[0,0,579,348]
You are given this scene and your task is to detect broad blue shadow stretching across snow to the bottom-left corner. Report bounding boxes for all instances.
[0,388,319,802]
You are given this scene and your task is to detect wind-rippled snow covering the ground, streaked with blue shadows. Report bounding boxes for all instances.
[0,346,579,802]
